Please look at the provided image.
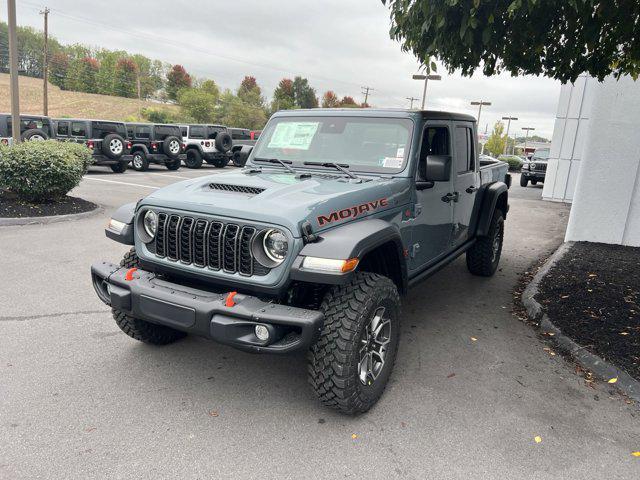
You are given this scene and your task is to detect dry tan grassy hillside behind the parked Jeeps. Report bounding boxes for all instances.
[0,73,178,121]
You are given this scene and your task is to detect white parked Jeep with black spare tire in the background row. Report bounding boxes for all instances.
[180,125,233,168]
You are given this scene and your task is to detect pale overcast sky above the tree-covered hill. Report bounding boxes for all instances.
[0,0,560,138]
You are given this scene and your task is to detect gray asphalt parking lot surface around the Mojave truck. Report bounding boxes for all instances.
[0,166,640,479]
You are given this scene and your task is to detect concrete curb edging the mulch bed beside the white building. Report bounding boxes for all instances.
[522,242,640,402]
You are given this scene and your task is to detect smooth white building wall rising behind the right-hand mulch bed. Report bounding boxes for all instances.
[564,77,640,246]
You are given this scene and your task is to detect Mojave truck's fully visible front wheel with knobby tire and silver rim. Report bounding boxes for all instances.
[308,272,400,415]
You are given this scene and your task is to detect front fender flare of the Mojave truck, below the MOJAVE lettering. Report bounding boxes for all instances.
[291,219,408,293]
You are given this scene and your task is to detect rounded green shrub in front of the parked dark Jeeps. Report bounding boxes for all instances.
[0,140,92,202]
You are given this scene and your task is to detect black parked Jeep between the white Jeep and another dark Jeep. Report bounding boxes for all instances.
[126,123,184,172]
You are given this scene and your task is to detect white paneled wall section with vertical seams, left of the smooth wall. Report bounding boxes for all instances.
[542,75,598,202]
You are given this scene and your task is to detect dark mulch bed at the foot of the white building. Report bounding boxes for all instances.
[536,242,640,380]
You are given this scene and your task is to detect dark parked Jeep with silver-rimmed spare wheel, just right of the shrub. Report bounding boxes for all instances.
[53,118,131,173]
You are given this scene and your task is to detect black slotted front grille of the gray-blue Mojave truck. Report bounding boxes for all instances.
[155,213,271,276]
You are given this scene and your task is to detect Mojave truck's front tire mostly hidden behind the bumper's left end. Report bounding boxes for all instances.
[111,248,187,345]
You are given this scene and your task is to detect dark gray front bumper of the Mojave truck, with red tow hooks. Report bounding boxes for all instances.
[91,262,324,353]
